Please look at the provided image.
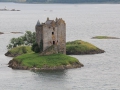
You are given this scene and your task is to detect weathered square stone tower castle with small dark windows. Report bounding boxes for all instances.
[35,18,66,54]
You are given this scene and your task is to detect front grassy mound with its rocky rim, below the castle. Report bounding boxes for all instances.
[8,53,84,70]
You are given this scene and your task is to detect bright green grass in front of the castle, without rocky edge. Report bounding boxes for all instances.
[13,53,79,68]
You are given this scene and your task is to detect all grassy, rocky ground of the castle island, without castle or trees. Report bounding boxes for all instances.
[5,40,105,70]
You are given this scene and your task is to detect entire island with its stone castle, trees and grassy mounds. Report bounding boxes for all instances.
[5,18,105,70]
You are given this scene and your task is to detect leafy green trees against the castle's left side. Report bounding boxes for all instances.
[7,31,35,49]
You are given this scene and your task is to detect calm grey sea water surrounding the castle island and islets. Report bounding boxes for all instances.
[0,3,120,90]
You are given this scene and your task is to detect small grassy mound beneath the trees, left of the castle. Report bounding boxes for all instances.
[8,46,33,55]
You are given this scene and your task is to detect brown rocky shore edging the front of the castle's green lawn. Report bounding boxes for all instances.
[8,60,84,71]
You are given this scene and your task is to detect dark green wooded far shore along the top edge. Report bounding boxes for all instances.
[0,0,120,3]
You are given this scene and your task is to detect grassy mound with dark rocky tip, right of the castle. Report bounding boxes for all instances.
[66,40,104,55]
